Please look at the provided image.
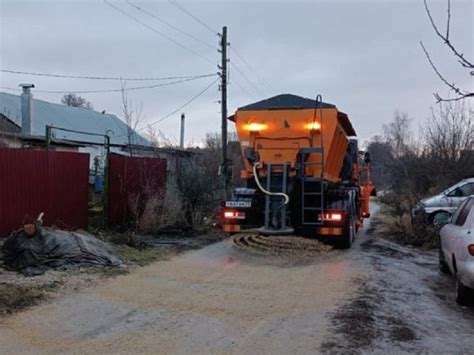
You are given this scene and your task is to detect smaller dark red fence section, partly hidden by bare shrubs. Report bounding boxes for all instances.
[108,154,166,226]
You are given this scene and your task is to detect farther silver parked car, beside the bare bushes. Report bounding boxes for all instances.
[412,178,474,224]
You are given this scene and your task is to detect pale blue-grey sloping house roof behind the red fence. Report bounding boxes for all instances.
[0,92,150,146]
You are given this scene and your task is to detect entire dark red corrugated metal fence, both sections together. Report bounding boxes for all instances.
[0,149,167,237]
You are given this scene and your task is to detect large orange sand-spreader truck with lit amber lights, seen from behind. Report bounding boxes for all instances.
[220,94,374,248]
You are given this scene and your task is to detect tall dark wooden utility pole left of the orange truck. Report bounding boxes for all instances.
[219,26,228,198]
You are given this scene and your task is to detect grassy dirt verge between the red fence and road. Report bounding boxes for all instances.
[0,230,222,318]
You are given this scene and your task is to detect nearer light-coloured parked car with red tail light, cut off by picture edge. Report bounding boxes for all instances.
[439,196,474,305]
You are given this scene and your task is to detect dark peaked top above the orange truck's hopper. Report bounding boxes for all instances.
[238,94,336,111]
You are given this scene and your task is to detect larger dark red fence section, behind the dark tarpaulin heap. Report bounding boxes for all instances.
[0,149,89,236]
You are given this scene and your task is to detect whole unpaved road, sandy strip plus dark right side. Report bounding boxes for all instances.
[0,207,474,354]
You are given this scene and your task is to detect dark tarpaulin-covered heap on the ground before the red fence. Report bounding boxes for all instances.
[2,228,123,276]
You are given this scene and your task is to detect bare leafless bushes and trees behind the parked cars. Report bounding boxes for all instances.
[368,102,474,248]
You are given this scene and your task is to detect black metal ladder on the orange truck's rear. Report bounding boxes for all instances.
[299,145,324,226]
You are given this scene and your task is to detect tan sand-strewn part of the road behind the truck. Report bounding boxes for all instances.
[0,241,357,353]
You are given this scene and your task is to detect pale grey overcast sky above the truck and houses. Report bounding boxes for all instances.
[0,0,474,143]
